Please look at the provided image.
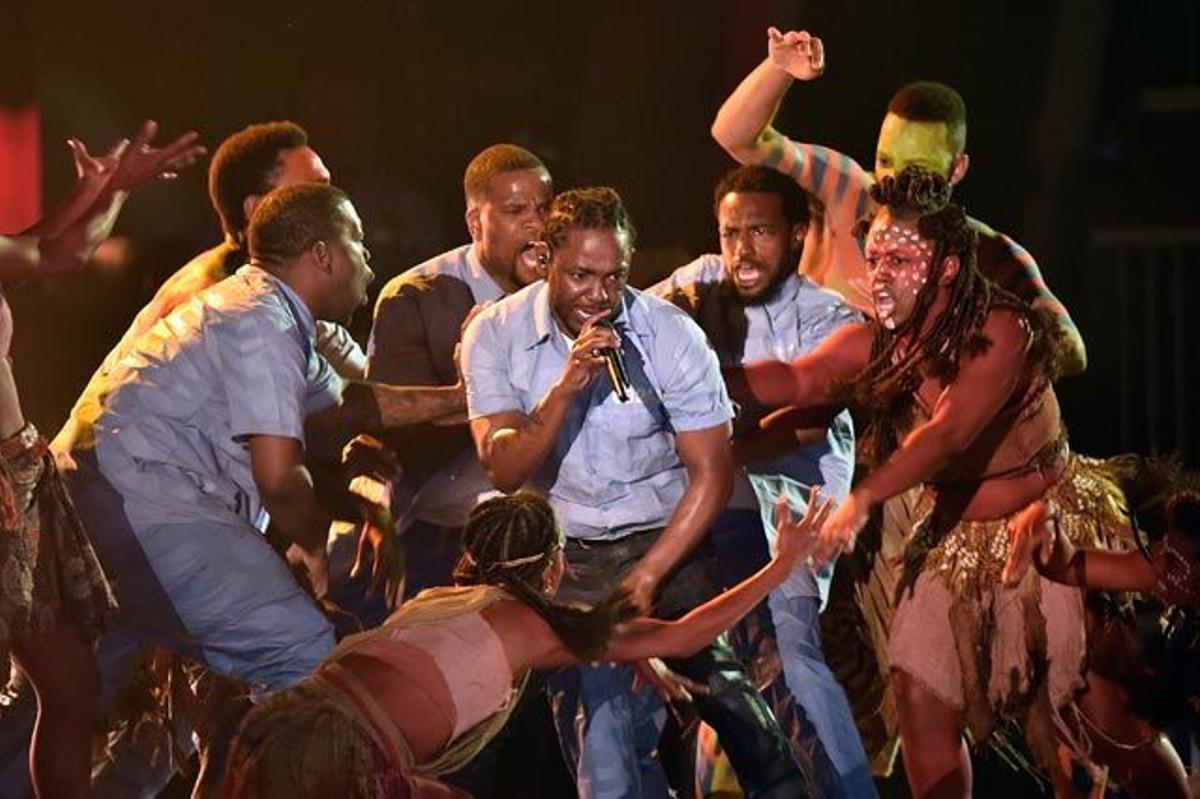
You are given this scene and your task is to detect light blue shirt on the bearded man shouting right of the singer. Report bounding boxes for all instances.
[648,254,862,595]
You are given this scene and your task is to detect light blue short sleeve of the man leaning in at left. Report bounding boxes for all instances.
[204,308,312,441]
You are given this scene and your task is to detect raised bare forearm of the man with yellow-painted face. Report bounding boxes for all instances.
[712,59,792,163]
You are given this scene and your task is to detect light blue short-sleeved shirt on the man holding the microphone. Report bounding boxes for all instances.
[463,282,732,540]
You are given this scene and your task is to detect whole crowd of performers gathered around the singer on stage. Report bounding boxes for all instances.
[0,29,1200,799]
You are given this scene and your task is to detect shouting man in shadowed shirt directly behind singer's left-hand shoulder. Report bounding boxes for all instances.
[367,144,553,596]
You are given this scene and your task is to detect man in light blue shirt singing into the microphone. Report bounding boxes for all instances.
[463,188,806,798]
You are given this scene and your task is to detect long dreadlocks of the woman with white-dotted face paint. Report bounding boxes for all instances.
[848,167,1054,464]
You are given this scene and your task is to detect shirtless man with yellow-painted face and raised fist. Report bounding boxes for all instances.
[712,29,1087,774]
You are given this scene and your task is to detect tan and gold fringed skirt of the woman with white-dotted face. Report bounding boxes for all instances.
[826,455,1128,774]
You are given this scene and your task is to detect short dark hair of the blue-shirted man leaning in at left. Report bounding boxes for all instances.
[247,184,350,268]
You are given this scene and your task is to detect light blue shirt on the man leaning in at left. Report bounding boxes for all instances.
[55,266,342,528]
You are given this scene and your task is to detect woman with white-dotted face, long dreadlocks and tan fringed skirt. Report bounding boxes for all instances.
[727,168,1190,797]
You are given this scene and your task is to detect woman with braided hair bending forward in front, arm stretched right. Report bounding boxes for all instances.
[220,493,829,799]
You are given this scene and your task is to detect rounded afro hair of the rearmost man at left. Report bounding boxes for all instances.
[209,121,308,242]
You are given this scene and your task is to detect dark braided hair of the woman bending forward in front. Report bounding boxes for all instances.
[454,492,634,660]
